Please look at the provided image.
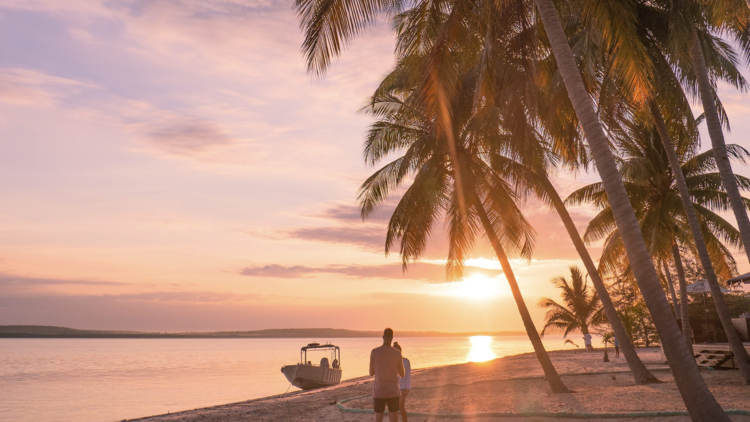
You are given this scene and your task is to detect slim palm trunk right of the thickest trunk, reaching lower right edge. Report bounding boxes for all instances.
[651,102,750,384]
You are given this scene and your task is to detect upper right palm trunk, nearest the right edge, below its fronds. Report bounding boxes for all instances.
[690,29,750,264]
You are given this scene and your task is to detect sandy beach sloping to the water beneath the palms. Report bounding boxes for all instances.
[131,348,750,422]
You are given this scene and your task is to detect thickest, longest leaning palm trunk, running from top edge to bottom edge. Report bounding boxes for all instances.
[535,0,730,422]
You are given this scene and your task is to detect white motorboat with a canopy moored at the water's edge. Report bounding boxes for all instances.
[281,343,341,390]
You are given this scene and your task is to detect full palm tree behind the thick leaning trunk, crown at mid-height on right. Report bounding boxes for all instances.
[568,120,750,341]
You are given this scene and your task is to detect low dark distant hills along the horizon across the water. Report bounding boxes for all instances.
[0,325,526,339]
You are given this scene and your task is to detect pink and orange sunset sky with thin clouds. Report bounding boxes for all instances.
[0,0,750,332]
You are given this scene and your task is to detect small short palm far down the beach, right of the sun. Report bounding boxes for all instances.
[539,265,607,338]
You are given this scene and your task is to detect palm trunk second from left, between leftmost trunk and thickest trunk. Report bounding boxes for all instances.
[541,175,659,384]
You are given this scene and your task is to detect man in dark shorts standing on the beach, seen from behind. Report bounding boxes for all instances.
[370,328,406,422]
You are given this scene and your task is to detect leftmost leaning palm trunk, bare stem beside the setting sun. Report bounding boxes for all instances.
[475,198,570,394]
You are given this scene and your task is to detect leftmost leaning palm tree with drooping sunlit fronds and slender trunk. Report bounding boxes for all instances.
[359,65,568,393]
